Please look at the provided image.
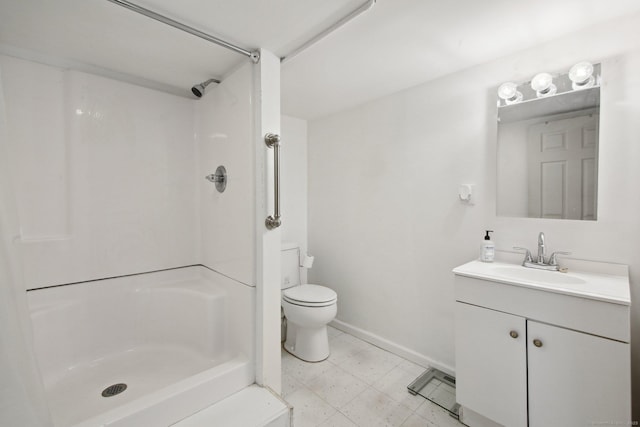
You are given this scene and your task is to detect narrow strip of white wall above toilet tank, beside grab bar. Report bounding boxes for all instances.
[280,116,308,283]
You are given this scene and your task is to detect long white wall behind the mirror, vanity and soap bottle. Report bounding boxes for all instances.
[309,15,640,417]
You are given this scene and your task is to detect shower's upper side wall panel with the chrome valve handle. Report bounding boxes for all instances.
[195,63,256,286]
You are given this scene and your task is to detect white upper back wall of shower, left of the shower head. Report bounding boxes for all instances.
[0,56,196,288]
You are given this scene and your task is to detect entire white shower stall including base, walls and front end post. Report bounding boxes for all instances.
[0,10,280,427]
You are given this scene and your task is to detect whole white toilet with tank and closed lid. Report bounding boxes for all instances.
[281,243,338,362]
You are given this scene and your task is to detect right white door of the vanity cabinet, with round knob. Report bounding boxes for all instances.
[527,321,631,427]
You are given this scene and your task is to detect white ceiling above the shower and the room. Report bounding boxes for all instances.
[0,0,640,119]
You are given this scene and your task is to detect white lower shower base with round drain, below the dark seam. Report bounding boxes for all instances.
[28,266,255,427]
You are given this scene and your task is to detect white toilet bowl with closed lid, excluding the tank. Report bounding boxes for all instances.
[282,284,338,362]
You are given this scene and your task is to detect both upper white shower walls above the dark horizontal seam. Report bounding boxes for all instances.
[0,56,256,289]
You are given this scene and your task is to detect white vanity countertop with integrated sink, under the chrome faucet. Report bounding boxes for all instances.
[453,260,631,305]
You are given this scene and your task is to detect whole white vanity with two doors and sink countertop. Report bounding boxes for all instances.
[454,261,631,427]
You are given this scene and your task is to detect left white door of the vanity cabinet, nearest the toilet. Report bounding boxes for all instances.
[455,302,528,427]
